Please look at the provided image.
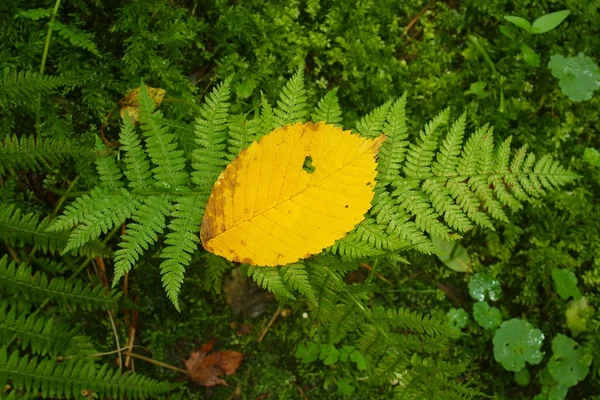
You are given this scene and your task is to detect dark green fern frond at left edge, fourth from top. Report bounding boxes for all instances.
[0,256,121,310]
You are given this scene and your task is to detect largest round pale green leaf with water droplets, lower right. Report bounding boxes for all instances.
[493,318,544,372]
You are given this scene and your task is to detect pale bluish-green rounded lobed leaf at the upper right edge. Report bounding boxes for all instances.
[548,53,600,101]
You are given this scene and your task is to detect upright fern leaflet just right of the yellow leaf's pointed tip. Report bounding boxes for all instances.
[377,93,408,182]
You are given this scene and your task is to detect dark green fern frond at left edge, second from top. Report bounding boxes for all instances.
[0,135,96,175]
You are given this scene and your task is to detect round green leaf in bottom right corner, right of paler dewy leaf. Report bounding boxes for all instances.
[548,334,592,386]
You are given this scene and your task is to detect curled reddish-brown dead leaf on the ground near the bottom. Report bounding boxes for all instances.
[185,339,244,387]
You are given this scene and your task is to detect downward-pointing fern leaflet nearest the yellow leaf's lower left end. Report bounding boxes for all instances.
[160,196,206,311]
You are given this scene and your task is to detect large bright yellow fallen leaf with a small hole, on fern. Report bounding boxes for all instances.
[200,122,385,266]
